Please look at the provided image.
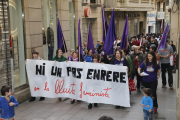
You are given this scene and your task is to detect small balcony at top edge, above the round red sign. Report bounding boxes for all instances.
[82,0,103,7]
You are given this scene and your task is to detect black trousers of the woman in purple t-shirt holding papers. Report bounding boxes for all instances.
[143,80,158,108]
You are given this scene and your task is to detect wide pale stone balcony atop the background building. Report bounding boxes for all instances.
[104,0,155,11]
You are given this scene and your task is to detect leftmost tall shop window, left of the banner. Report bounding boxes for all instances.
[9,0,26,88]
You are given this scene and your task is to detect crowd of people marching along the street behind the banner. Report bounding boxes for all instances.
[0,34,176,119]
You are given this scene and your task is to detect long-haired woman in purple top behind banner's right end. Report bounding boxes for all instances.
[110,49,130,109]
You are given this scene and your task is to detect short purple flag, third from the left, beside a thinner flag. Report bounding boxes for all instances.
[87,23,95,53]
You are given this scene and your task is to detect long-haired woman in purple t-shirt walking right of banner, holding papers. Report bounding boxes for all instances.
[138,51,161,113]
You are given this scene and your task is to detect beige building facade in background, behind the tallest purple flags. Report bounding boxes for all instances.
[104,0,155,37]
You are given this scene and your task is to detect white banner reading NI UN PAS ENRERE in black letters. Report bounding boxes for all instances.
[26,59,130,107]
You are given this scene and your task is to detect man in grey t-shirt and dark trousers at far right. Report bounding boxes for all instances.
[158,40,173,89]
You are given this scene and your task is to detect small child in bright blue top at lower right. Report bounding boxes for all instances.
[141,88,153,120]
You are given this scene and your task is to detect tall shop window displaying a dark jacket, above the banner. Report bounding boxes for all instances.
[41,0,57,60]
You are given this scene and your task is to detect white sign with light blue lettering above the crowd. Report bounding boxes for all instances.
[147,12,156,26]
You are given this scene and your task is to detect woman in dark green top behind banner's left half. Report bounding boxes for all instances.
[53,48,68,102]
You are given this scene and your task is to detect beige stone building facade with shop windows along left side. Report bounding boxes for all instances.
[0,0,103,103]
